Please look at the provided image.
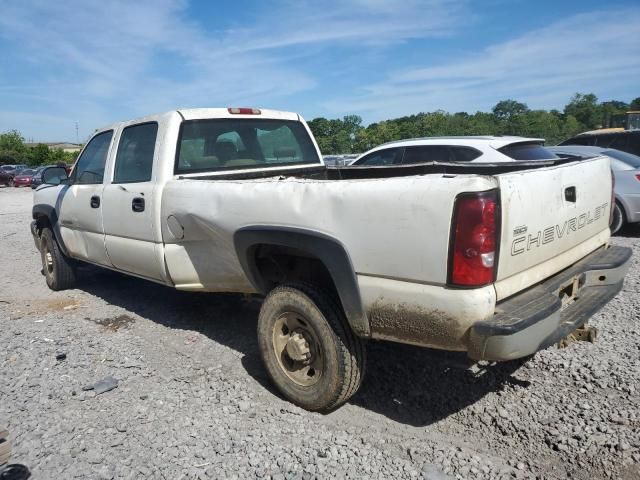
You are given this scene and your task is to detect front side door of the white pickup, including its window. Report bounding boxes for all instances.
[56,130,113,266]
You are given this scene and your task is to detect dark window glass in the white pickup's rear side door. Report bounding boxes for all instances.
[113,122,158,183]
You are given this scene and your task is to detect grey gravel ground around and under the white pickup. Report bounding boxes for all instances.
[0,188,640,480]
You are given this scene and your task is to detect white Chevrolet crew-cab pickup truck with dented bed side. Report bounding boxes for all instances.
[32,108,631,410]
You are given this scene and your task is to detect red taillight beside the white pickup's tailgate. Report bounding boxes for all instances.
[449,190,500,287]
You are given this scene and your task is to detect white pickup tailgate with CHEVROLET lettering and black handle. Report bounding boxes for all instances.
[496,157,611,299]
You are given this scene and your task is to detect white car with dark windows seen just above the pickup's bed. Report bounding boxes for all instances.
[351,136,557,166]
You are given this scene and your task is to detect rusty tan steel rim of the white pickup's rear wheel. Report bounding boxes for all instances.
[272,312,324,387]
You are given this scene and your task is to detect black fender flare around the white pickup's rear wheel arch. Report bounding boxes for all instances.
[234,226,370,337]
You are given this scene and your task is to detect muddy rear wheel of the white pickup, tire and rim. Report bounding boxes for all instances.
[258,284,366,411]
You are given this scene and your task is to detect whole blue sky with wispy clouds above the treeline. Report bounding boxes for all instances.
[0,0,640,141]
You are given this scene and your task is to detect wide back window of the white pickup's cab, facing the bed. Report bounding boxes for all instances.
[175,119,320,173]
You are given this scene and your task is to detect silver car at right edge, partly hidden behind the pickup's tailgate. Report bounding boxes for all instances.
[549,145,640,233]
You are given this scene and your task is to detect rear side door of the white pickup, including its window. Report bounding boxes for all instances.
[103,122,164,280]
